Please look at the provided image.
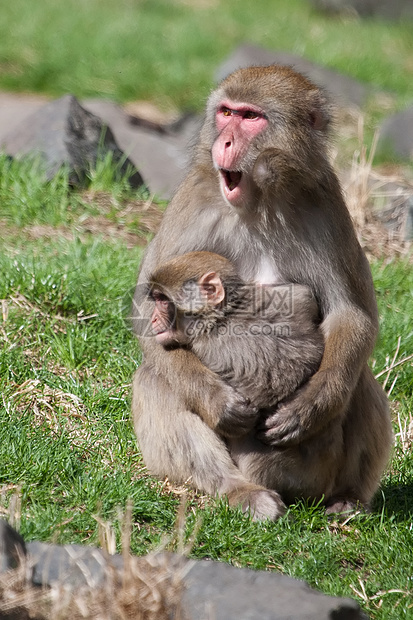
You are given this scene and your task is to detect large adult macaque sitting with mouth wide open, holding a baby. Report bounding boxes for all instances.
[133,66,392,518]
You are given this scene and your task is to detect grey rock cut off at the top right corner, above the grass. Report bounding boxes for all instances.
[311,0,413,19]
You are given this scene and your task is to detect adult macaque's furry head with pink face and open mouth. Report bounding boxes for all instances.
[201,65,330,208]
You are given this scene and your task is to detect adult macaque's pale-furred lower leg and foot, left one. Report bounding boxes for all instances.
[132,363,285,519]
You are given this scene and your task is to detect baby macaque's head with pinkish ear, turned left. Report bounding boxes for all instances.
[149,252,239,348]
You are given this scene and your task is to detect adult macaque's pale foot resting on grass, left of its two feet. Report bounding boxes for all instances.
[228,486,286,521]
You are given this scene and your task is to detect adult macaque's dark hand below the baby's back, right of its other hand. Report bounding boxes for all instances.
[256,371,349,447]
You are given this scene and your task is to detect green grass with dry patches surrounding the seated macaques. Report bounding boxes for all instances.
[0,154,413,620]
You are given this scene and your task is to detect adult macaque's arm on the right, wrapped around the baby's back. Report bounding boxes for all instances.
[256,149,378,446]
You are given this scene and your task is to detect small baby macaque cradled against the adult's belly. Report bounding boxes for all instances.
[150,252,323,437]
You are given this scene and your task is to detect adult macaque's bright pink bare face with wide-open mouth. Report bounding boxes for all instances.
[212,100,268,206]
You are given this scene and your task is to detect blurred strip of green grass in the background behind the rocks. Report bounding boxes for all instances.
[0,0,413,109]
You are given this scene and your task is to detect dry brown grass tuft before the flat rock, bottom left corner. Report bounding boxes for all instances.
[0,554,188,620]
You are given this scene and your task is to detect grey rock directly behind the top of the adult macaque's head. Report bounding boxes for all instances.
[215,44,371,106]
